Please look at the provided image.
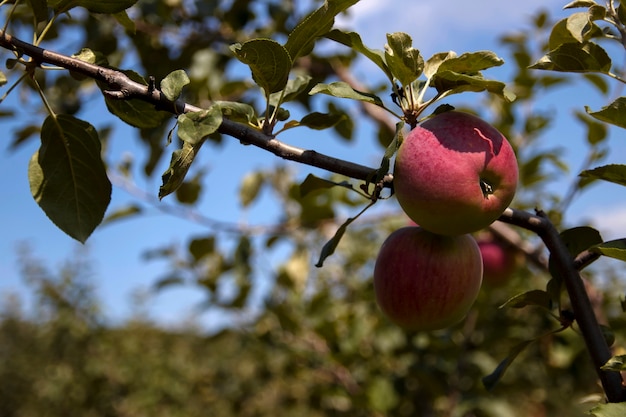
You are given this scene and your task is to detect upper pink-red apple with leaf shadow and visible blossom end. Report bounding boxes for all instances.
[393,111,518,235]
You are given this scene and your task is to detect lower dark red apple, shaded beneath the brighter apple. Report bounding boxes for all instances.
[374,226,483,331]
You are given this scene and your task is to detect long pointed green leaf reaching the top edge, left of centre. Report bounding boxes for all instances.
[285,0,359,61]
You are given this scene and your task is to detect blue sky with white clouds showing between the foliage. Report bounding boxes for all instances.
[0,0,626,324]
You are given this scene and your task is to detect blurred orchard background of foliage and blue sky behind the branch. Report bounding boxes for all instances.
[0,0,626,416]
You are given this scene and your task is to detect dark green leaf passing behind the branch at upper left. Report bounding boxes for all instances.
[98,71,172,129]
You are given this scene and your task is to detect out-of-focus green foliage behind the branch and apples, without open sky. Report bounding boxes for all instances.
[0,0,626,417]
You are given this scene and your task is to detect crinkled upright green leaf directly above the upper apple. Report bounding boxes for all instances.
[385,32,424,86]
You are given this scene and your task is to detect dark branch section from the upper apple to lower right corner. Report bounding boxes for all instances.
[499,208,626,402]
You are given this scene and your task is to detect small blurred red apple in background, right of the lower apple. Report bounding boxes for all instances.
[476,237,517,287]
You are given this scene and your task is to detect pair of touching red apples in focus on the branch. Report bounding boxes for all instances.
[374,111,518,330]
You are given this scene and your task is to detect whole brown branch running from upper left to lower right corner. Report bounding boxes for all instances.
[0,30,626,402]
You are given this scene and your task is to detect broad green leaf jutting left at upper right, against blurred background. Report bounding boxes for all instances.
[530,43,611,73]
